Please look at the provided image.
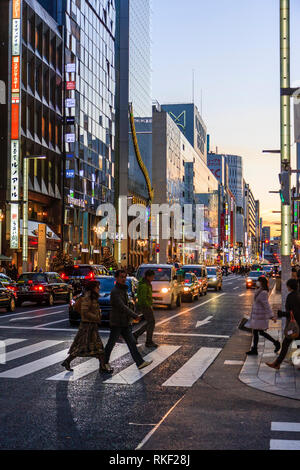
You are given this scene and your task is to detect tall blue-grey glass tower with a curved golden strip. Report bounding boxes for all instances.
[115,0,153,266]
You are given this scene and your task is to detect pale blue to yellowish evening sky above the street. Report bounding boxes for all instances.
[152,0,300,236]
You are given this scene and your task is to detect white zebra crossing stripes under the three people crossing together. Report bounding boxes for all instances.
[0,338,222,387]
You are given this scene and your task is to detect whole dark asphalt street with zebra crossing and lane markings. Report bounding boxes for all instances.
[0,275,300,450]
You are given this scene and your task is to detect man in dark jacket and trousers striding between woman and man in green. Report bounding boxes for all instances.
[105,269,152,369]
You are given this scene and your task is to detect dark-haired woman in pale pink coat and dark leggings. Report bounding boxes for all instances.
[247,276,280,356]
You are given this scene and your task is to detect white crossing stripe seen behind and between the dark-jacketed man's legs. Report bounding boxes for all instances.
[47,343,129,382]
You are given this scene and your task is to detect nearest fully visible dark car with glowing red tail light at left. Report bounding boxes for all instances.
[16,272,73,306]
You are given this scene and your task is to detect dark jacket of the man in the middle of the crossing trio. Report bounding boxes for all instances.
[109,283,139,328]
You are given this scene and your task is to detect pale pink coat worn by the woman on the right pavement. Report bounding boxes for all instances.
[247,289,274,330]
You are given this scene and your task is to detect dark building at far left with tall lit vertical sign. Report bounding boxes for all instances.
[0,0,63,268]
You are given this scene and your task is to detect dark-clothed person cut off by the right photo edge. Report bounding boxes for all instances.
[266,279,300,370]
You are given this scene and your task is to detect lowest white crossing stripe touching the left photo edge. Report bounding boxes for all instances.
[0,349,69,379]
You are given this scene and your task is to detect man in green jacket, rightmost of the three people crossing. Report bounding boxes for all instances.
[133,269,158,349]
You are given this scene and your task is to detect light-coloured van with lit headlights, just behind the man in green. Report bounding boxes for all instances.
[136,264,183,309]
